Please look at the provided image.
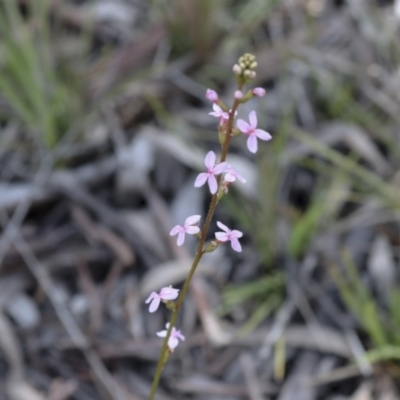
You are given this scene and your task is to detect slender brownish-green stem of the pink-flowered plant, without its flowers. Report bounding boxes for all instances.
[149,94,242,400]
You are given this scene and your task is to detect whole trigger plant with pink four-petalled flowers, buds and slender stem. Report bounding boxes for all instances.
[146,54,271,400]
